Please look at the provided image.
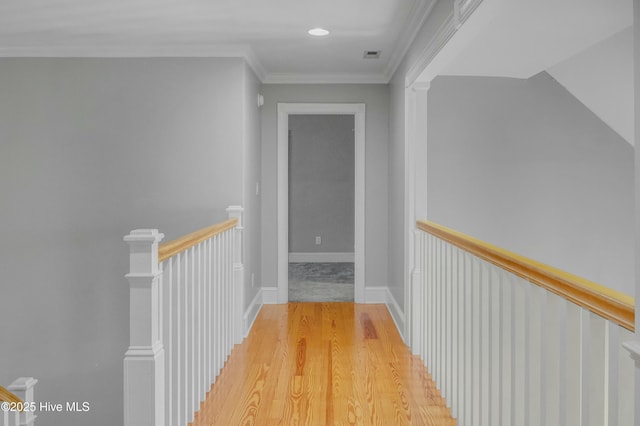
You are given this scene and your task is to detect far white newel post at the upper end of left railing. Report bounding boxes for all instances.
[227,206,246,344]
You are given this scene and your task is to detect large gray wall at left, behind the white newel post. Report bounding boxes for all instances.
[0,59,248,426]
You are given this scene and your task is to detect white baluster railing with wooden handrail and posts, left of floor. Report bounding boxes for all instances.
[124,206,244,426]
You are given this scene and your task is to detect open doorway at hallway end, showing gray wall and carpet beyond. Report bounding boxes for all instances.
[288,114,355,302]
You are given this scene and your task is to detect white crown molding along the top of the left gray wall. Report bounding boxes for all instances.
[0,44,267,82]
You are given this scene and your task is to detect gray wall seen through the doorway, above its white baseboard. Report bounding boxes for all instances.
[289,115,355,253]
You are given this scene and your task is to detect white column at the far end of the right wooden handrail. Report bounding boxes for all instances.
[404,82,429,355]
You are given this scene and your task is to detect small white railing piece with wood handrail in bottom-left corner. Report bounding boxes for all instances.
[0,377,39,426]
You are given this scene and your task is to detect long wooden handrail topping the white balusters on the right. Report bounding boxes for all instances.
[417,220,635,332]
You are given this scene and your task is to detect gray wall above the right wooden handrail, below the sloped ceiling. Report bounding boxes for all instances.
[427,73,634,294]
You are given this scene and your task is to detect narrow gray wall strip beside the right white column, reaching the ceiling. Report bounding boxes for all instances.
[387,0,453,310]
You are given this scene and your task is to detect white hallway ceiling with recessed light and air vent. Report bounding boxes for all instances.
[0,0,432,82]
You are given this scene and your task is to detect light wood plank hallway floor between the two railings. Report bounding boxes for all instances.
[193,303,456,426]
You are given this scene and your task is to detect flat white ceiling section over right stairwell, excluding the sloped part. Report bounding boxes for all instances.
[442,0,633,78]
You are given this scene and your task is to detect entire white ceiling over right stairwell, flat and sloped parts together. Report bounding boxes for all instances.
[441,0,635,145]
